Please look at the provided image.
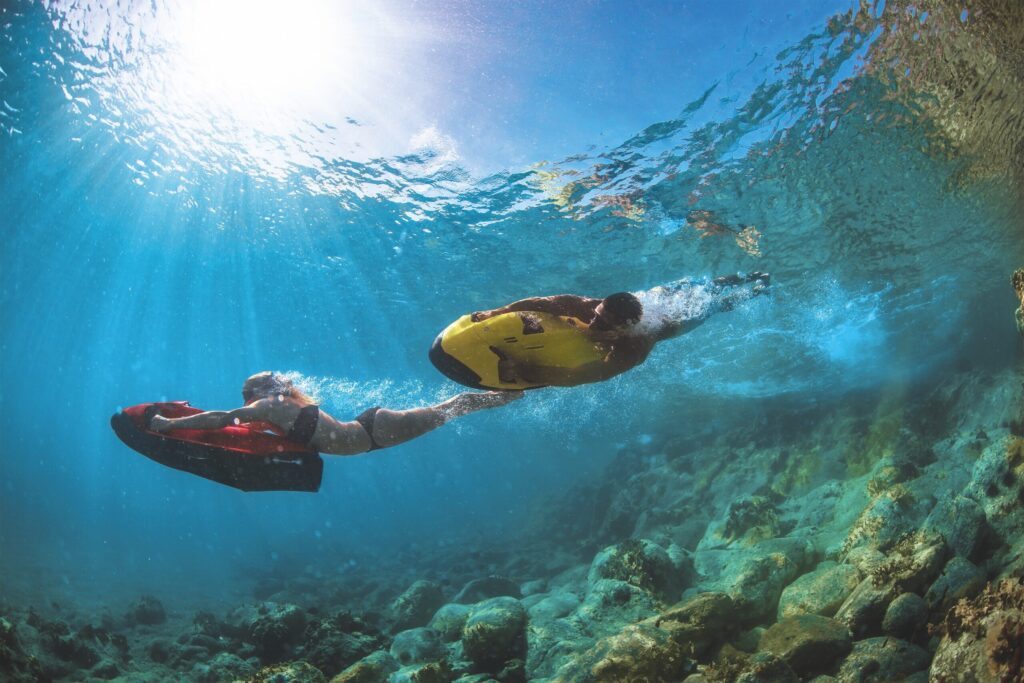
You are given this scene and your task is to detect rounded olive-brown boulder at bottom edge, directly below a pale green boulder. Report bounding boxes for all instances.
[759,614,851,678]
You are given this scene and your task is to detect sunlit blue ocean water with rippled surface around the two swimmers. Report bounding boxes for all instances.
[0,0,1024,680]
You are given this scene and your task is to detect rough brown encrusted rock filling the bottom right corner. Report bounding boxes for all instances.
[931,578,1024,682]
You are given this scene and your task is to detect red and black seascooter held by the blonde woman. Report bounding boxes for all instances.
[111,400,324,492]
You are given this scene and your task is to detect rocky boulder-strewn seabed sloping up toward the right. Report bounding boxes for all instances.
[0,362,1024,683]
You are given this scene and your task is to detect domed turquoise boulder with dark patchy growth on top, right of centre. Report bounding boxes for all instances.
[587,539,685,600]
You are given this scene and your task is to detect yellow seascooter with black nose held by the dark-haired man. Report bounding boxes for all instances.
[430,311,607,389]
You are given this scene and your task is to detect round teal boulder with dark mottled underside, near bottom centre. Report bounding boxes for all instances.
[462,597,526,671]
